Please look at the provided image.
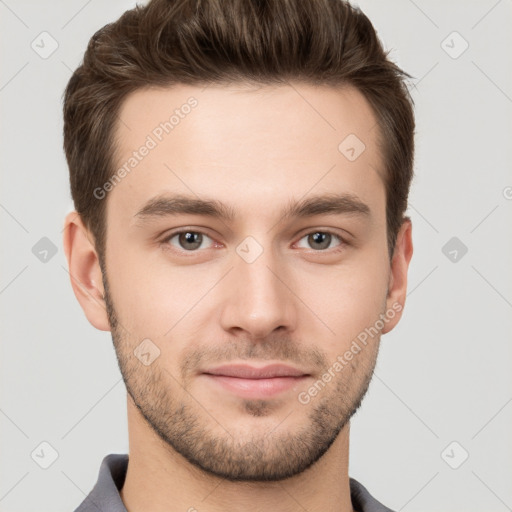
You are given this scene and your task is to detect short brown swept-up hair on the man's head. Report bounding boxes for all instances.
[64,0,415,263]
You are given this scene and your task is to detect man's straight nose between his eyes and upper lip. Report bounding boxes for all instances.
[221,243,297,339]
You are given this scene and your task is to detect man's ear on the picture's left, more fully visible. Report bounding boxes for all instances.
[63,211,110,331]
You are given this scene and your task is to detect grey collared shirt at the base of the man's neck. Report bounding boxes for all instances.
[75,453,393,512]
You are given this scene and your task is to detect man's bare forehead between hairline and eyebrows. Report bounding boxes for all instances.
[108,84,383,221]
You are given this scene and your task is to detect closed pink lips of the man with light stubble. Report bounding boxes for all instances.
[202,364,311,399]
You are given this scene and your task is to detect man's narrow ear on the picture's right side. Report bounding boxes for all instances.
[382,217,413,334]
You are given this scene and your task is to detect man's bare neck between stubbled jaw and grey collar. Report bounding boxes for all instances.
[120,399,353,512]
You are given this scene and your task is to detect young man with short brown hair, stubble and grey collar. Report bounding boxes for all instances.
[64,0,414,512]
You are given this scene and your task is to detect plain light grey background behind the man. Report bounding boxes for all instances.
[0,0,512,512]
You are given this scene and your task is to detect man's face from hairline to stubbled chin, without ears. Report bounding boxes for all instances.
[104,85,392,480]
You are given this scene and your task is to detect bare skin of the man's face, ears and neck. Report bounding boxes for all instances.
[64,84,412,512]
